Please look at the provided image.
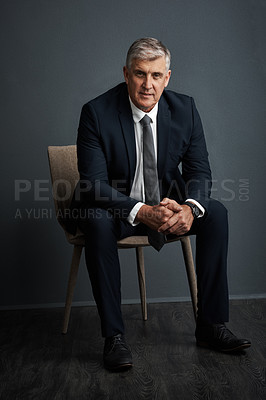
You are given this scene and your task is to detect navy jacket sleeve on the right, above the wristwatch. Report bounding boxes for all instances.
[182,98,212,210]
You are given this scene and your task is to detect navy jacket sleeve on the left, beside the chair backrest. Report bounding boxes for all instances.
[75,103,137,219]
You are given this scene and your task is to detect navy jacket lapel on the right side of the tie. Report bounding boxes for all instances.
[157,95,171,180]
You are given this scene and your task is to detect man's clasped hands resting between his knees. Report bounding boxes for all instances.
[136,197,194,236]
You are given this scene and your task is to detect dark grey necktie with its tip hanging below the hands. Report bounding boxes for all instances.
[140,114,165,251]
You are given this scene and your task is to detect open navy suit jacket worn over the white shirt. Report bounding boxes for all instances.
[70,83,211,230]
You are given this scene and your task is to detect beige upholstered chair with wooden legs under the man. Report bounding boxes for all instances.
[48,145,197,333]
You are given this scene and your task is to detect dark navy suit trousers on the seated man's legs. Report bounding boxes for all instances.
[79,199,229,337]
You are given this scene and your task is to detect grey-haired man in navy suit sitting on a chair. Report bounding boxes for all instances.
[74,38,250,370]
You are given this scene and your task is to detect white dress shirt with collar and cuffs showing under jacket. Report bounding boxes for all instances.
[127,98,205,226]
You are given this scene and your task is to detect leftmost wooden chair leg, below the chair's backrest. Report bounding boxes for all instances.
[62,245,82,334]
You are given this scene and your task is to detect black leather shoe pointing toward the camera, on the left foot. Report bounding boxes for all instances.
[103,333,132,371]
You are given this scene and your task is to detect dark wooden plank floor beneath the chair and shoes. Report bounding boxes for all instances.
[0,299,266,400]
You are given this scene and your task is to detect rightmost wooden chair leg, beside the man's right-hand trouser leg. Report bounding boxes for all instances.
[180,236,197,320]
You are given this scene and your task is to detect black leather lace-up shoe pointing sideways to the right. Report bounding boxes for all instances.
[195,324,251,352]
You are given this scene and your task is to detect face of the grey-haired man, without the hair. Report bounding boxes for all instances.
[123,57,171,112]
